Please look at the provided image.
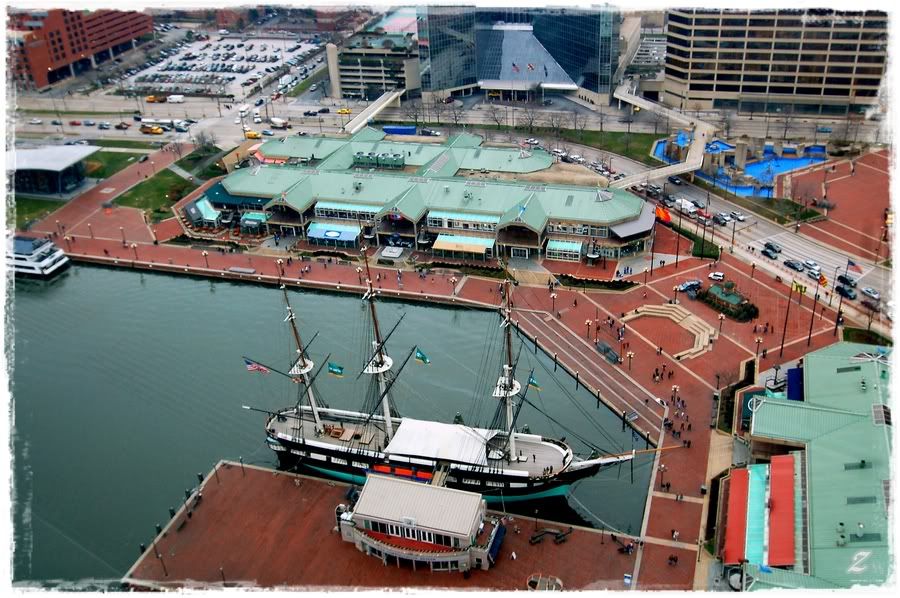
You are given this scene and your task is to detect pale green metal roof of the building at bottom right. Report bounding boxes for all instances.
[751,343,892,588]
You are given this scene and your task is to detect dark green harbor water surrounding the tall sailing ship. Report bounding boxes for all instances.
[11,266,650,582]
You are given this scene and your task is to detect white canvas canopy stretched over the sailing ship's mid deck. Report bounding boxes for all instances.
[384,417,498,465]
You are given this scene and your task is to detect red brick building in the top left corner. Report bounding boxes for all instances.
[6,9,153,89]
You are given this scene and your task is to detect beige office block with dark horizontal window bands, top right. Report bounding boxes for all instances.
[663,9,888,117]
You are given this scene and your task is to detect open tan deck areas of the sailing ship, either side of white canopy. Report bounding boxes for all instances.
[269,408,565,477]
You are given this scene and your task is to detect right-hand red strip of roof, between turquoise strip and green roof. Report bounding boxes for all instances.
[768,455,794,566]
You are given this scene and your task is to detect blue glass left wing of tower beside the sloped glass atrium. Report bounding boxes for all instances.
[416,6,477,91]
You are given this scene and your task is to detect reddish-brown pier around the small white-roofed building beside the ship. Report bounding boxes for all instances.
[123,462,637,590]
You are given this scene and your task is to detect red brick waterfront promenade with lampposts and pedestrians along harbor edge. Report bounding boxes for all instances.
[26,164,856,589]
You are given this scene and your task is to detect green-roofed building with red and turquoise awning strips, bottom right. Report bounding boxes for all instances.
[719,343,894,590]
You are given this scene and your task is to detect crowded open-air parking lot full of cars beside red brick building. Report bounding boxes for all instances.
[120,35,319,99]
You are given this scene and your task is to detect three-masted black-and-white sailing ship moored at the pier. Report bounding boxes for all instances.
[245,263,635,503]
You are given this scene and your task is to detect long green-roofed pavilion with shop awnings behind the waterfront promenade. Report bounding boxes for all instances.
[214,129,655,261]
